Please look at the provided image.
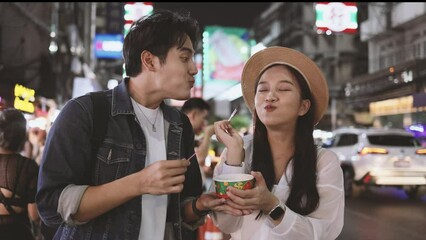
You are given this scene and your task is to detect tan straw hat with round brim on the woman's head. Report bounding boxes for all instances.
[241,46,328,125]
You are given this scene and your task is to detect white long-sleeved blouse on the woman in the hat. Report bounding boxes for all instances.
[210,135,345,240]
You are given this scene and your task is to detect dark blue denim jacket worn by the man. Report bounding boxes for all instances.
[36,78,202,240]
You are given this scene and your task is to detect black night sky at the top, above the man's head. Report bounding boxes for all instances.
[154,2,270,28]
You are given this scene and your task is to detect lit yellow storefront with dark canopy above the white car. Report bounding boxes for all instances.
[344,59,426,128]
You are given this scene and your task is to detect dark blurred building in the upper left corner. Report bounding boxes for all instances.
[0,2,96,107]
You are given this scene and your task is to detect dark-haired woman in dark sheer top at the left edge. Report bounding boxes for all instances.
[0,109,39,240]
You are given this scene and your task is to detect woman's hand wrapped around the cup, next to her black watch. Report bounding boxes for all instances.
[226,171,279,213]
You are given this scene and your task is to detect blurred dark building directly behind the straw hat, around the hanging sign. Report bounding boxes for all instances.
[253,2,368,130]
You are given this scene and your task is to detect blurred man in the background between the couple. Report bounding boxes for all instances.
[181,97,214,190]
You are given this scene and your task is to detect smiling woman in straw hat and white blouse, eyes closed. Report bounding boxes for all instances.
[212,47,344,240]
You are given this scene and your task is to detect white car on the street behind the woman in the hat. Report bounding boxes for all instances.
[326,128,426,198]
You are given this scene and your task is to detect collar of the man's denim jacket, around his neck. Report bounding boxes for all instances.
[111,77,182,125]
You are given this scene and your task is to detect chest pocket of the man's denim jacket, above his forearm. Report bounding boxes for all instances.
[95,139,132,184]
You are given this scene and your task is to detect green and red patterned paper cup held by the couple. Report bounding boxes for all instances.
[213,173,255,198]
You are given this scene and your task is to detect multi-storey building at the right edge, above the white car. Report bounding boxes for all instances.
[343,2,426,128]
